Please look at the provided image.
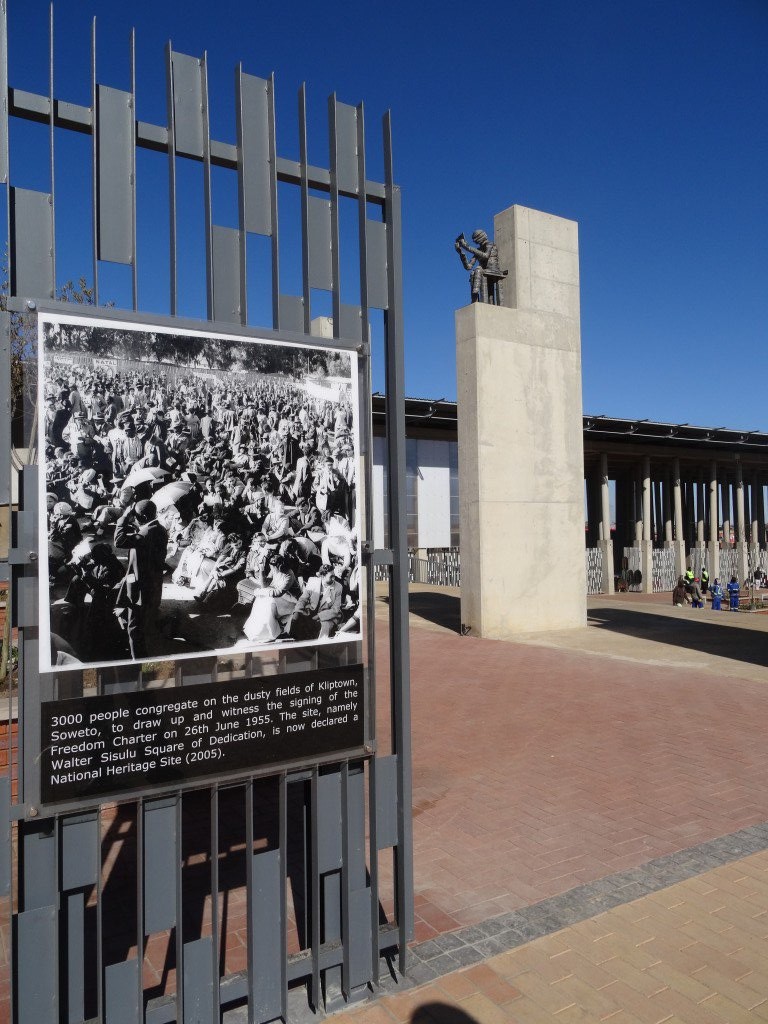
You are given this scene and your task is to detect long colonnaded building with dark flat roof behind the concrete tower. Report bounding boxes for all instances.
[374,396,768,594]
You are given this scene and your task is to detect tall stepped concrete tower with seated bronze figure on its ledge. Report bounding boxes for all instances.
[456,206,587,639]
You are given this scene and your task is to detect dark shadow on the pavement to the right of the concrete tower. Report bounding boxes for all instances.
[589,608,768,667]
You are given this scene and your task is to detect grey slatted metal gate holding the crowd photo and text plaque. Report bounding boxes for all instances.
[0,0,413,1024]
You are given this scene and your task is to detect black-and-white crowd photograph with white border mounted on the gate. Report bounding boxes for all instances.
[38,314,361,672]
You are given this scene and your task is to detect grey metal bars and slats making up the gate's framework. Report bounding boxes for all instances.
[0,0,414,1024]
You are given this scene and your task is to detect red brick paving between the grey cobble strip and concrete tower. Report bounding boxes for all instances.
[0,598,768,1020]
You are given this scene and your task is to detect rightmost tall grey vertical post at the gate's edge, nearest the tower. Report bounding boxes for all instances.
[383,112,414,973]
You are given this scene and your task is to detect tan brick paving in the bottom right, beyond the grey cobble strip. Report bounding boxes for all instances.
[344,851,768,1024]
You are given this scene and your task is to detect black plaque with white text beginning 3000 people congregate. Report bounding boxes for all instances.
[41,665,365,804]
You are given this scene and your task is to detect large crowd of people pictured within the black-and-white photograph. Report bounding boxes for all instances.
[41,365,359,664]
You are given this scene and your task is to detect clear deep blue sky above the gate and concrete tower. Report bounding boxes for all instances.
[8,0,768,429]
